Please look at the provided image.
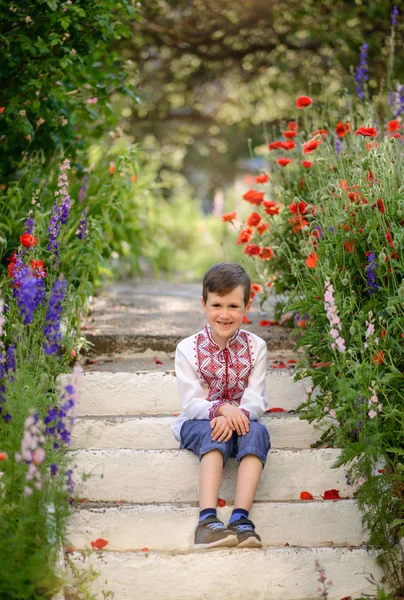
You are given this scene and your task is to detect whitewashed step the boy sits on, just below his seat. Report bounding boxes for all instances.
[71,413,321,450]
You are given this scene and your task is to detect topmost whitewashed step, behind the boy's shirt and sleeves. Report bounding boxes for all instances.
[68,371,311,416]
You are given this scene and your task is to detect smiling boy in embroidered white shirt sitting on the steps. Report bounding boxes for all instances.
[172,263,270,548]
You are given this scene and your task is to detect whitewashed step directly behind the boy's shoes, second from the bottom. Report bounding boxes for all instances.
[67,500,365,551]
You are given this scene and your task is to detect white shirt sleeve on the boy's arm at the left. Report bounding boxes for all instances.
[175,346,216,419]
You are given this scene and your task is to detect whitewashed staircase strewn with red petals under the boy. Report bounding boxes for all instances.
[68,369,381,600]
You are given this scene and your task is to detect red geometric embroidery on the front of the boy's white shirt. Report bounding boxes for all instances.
[196,327,253,412]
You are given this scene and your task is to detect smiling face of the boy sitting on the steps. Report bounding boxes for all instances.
[202,285,252,348]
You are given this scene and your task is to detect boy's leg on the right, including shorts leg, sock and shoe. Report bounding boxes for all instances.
[229,421,271,548]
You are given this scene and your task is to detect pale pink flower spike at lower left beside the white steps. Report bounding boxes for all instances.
[15,414,46,496]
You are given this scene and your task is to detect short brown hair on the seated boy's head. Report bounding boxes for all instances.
[202,263,251,306]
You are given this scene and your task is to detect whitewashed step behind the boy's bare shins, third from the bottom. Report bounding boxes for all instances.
[71,448,352,503]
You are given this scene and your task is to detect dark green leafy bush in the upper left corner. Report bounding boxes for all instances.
[0,0,137,177]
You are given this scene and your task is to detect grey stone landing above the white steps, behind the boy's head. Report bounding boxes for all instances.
[82,280,294,360]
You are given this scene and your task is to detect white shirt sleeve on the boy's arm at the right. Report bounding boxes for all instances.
[240,343,268,421]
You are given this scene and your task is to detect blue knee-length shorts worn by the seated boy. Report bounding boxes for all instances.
[180,419,271,467]
